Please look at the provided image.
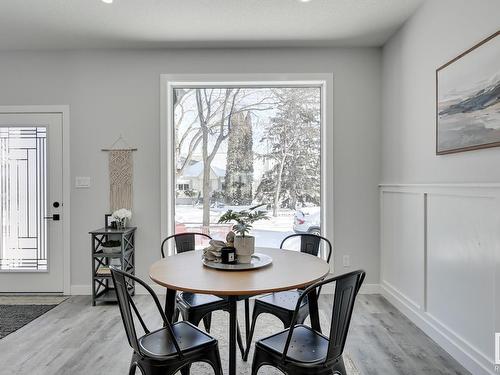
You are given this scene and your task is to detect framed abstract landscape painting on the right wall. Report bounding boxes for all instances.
[436,31,500,155]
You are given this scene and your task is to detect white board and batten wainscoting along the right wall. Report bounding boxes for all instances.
[380,183,500,375]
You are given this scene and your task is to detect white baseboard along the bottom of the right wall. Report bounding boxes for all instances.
[380,284,495,375]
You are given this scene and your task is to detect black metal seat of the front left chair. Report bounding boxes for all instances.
[138,321,217,359]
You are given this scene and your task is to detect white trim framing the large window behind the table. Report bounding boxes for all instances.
[160,73,335,262]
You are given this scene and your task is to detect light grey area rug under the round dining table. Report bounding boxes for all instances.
[191,304,360,375]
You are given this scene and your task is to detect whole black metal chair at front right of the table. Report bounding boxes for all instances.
[252,270,365,375]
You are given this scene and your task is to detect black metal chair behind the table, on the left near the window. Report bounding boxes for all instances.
[161,232,244,356]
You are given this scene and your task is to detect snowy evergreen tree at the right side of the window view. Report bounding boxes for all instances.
[256,88,321,216]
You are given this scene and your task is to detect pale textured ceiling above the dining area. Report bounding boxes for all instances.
[0,0,423,50]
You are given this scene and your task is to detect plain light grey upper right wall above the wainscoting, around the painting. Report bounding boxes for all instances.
[382,0,500,183]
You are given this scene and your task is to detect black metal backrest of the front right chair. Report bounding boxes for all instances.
[283,270,365,362]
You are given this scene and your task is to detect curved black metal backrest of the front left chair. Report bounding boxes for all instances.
[110,266,182,357]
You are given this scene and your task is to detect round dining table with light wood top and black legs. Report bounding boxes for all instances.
[149,247,330,375]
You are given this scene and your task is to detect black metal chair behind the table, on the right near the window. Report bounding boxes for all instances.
[243,234,333,361]
